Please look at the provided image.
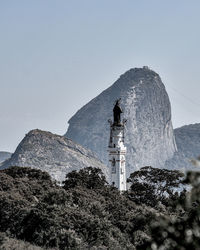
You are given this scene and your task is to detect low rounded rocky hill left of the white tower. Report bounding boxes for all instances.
[0,130,107,181]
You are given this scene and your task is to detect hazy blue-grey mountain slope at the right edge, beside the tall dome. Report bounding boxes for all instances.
[165,123,200,171]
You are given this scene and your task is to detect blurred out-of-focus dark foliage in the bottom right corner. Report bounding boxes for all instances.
[141,172,200,250]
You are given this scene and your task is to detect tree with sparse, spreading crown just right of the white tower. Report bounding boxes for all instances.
[127,166,184,207]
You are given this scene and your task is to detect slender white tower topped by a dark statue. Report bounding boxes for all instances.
[108,99,126,191]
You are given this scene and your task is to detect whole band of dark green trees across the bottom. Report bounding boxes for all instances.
[0,167,200,250]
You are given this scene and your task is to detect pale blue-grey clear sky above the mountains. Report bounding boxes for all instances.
[0,0,200,152]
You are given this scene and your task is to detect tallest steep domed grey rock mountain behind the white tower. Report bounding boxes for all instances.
[65,67,176,175]
